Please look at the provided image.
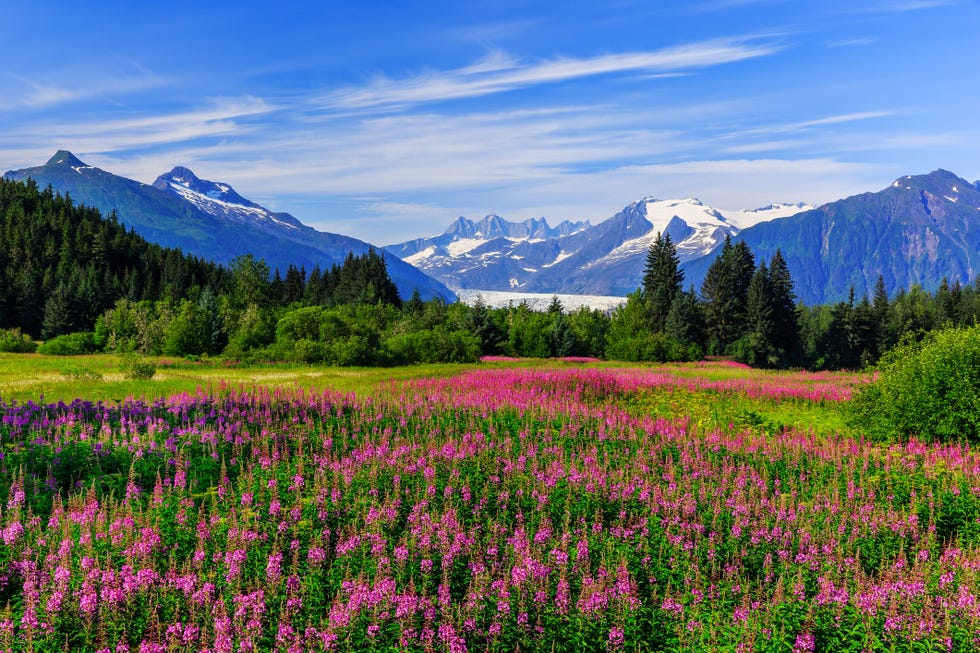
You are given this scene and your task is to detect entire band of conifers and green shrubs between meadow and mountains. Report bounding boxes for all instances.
[0,180,980,369]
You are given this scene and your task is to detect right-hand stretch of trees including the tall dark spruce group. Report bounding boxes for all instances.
[606,234,980,369]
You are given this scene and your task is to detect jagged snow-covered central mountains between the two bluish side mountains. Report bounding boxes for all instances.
[386,197,812,295]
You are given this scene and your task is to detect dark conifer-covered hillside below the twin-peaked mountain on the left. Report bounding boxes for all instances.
[0,179,229,337]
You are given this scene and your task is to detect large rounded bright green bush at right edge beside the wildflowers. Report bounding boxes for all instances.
[851,327,980,440]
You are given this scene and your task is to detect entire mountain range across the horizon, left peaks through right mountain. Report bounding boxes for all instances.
[4,150,980,304]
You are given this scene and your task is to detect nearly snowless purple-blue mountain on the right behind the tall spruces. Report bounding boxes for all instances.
[683,170,980,304]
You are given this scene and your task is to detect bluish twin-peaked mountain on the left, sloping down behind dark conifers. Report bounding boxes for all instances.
[4,150,454,300]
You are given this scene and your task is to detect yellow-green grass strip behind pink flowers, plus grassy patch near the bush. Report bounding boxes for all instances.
[0,353,865,433]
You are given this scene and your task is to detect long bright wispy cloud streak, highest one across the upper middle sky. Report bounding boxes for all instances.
[323,39,781,110]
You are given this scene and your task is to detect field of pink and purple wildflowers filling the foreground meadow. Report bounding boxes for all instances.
[0,362,980,653]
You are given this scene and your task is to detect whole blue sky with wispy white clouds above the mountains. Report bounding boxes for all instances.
[0,0,980,244]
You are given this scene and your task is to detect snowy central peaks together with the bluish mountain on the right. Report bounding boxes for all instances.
[386,170,980,305]
